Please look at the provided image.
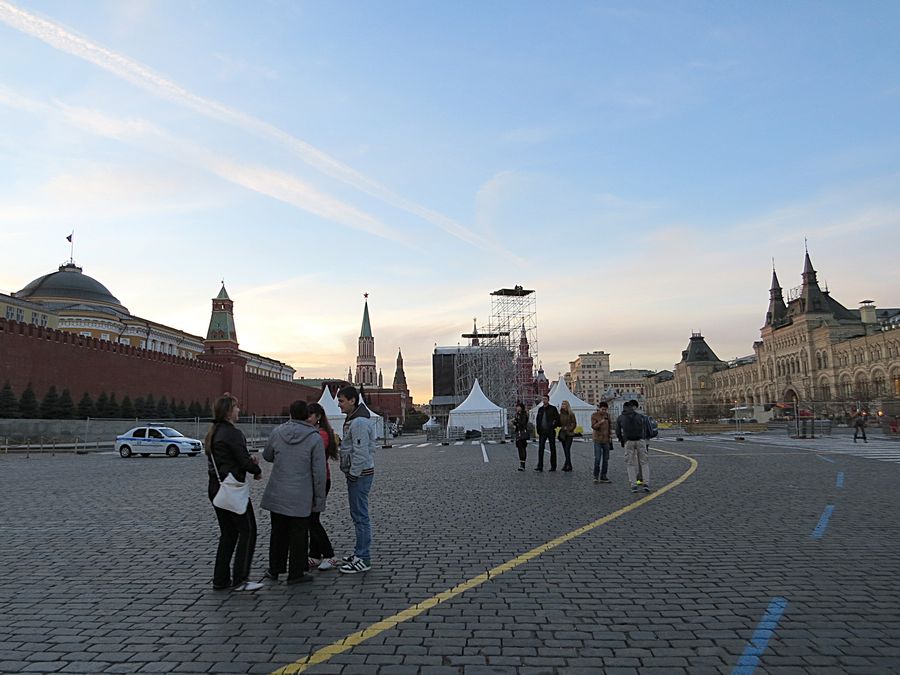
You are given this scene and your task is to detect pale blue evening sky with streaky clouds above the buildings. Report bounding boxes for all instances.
[0,0,900,403]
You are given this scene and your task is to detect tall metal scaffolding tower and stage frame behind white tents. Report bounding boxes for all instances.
[454,286,537,414]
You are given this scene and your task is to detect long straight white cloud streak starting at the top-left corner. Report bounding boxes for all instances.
[0,0,523,263]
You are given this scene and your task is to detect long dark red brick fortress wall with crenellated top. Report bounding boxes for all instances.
[0,318,320,415]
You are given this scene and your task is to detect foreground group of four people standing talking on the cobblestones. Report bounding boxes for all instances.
[205,387,376,591]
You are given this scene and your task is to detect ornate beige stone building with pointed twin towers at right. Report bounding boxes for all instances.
[645,252,900,419]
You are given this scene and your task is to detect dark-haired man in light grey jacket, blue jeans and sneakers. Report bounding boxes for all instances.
[338,387,376,574]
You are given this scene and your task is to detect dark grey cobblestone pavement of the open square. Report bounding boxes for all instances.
[0,436,900,675]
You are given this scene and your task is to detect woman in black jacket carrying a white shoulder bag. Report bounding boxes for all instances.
[209,393,262,591]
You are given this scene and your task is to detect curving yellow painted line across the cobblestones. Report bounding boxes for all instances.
[272,448,697,675]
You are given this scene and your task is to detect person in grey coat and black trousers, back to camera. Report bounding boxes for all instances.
[261,401,326,584]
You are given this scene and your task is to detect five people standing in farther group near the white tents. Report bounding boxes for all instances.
[513,394,654,492]
